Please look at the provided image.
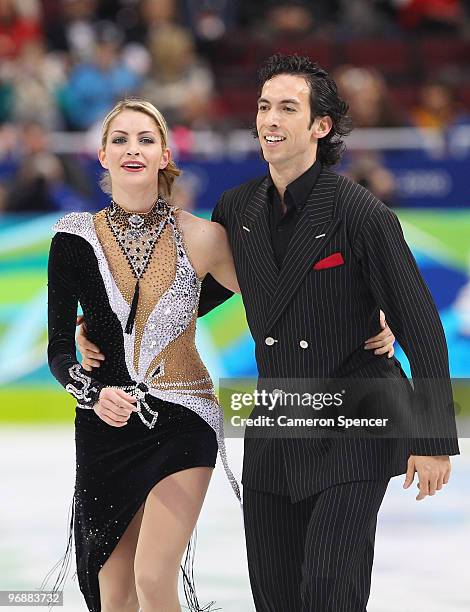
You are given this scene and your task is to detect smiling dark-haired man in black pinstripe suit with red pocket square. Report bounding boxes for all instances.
[78,55,459,612]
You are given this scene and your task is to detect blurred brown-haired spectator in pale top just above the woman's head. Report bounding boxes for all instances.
[141,26,214,127]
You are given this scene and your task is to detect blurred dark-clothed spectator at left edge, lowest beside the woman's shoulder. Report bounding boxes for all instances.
[5,123,92,212]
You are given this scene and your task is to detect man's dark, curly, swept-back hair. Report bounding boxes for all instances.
[255,53,352,166]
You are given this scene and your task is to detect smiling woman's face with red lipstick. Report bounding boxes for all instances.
[98,109,170,191]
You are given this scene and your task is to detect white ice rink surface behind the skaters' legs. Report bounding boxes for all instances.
[0,425,470,612]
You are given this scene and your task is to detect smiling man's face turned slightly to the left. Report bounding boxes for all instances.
[256,74,317,170]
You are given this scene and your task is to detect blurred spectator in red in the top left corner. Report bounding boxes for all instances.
[0,0,42,60]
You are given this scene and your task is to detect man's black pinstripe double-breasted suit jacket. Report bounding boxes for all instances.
[202,169,459,501]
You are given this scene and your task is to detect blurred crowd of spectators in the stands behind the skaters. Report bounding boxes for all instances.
[0,0,470,210]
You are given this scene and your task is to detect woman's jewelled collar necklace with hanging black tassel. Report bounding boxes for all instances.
[106,197,171,334]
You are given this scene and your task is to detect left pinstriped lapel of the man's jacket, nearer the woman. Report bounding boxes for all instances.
[241,178,279,295]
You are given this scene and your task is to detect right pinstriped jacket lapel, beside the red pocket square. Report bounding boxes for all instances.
[266,170,341,332]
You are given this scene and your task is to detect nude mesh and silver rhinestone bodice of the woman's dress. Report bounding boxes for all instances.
[98,211,207,385]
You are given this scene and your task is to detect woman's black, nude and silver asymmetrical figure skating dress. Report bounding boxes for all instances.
[48,198,240,612]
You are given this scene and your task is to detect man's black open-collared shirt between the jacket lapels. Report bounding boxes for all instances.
[268,160,321,268]
